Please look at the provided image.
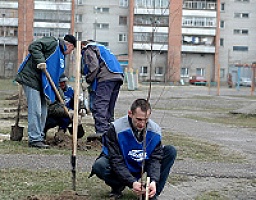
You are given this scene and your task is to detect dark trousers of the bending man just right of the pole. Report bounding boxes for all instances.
[92,81,122,134]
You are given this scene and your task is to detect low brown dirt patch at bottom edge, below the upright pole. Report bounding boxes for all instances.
[27,191,90,200]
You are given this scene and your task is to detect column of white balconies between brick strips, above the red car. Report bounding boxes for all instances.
[181,0,219,82]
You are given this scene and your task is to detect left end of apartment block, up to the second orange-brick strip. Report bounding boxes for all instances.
[0,0,72,77]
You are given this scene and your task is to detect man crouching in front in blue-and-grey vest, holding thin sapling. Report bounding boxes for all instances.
[91,99,177,199]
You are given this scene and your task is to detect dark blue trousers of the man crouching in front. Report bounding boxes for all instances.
[92,145,177,195]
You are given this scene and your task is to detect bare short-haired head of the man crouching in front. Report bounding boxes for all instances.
[128,99,151,131]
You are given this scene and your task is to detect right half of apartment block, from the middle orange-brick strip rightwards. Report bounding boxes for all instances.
[129,0,256,82]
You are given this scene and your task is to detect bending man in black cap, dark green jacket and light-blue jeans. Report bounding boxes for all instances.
[15,35,76,149]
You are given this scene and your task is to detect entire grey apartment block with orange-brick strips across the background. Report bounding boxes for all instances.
[0,0,256,82]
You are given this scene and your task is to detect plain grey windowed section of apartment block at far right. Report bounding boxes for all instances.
[219,0,256,83]
